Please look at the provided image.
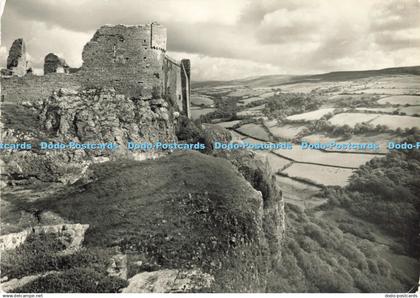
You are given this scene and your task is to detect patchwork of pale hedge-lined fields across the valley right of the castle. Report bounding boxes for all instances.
[193,67,420,199]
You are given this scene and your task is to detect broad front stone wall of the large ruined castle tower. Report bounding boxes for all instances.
[79,24,166,97]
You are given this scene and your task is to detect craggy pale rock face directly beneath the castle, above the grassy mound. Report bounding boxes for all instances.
[2,88,176,183]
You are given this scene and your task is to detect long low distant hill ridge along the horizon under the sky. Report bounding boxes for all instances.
[192,66,420,88]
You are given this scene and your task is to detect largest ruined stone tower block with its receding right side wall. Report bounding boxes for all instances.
[81,23,190,116]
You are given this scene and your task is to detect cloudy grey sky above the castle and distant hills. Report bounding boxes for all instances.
[0,0,420,80]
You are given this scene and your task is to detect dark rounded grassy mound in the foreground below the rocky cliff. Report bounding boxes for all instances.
[34,152,267,291]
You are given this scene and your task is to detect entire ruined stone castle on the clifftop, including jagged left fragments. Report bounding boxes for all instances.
[1,23,191,117]
